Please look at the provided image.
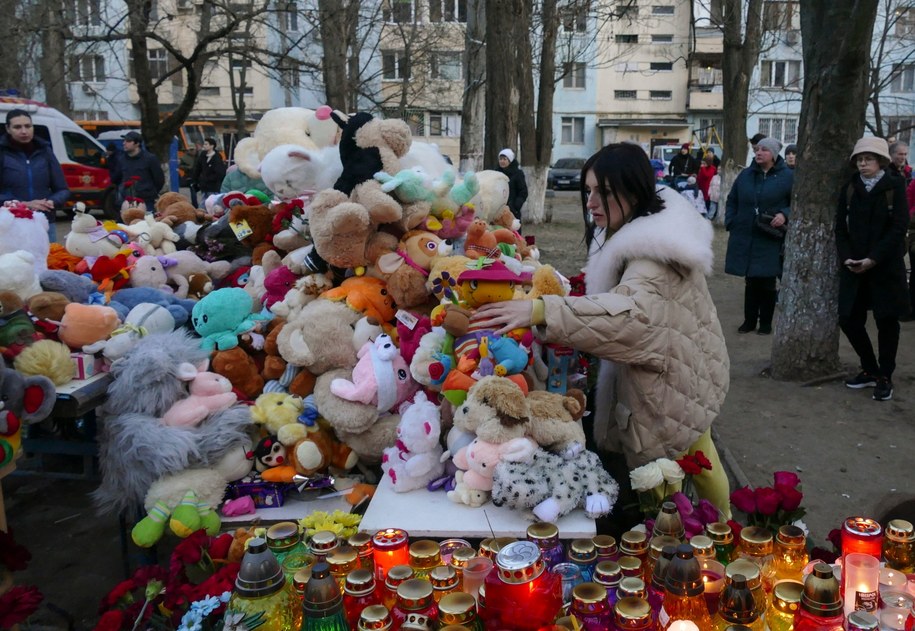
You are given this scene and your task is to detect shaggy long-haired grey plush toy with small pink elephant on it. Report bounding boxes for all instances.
[93,330,251,512]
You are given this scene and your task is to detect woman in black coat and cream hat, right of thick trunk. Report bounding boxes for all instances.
[836,136,910,401]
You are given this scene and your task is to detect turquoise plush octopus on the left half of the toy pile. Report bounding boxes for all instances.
[191,287,267,351]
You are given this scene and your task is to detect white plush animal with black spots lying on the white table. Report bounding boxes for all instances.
[492,449,619,522]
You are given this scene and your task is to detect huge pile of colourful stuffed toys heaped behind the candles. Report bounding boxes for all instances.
[0,107,617,546]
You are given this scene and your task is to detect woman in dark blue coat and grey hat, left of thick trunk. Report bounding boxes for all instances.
[724,138,794,335]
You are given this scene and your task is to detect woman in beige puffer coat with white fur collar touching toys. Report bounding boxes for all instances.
[474,144,730,515]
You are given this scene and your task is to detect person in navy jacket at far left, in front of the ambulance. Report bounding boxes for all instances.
[0,109,70,243]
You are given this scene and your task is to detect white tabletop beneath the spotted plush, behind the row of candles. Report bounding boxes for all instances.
[359,476,597,539]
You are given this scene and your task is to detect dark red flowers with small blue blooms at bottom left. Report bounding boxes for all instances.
[95,530,239,631]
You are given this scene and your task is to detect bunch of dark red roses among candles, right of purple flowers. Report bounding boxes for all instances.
[731,471,807,532]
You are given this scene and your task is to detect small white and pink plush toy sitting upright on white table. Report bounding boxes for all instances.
[381,392,445,493]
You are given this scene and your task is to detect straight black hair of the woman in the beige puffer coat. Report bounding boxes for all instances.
[581,142,664,248]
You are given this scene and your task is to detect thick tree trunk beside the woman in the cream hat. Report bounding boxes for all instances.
[772,0,877,379]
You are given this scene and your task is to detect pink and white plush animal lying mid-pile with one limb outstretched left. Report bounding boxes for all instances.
[330,334,419,412]
